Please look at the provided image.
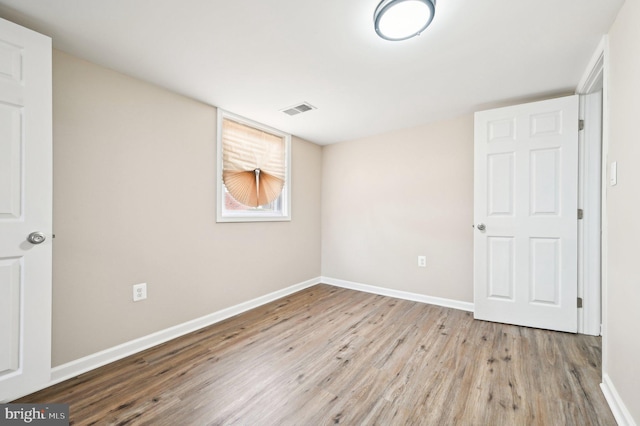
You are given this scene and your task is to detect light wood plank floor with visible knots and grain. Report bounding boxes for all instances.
[18,285,615,426]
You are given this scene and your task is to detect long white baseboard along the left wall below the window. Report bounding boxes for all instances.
[47,277,321,392]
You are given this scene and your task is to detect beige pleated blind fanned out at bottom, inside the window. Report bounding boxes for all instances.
[222,118,285,207]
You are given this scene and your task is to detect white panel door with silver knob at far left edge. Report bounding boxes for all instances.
[0,19,52,402]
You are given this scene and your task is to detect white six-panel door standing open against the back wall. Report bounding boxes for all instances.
[474,96,579,333]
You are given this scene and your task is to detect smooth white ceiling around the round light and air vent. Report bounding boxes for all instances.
[0,0,624,144]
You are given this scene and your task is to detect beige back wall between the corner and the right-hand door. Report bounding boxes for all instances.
[322,115,473,302]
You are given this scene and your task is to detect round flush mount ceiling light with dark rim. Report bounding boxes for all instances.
[373,0,436,41]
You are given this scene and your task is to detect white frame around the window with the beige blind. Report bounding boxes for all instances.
[216,108,291,223]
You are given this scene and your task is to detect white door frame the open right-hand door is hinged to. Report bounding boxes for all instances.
[576,35,609,336]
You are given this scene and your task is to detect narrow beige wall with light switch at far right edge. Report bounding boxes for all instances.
[604,1,640,424]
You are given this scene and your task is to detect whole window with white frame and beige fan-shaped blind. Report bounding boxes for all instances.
[217,109,291,222]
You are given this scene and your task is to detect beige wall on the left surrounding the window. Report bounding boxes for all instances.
[53,51,322,366]
